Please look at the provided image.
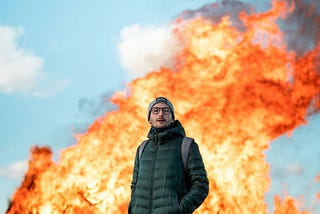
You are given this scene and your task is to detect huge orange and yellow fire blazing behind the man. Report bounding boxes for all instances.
[7,1,320,214]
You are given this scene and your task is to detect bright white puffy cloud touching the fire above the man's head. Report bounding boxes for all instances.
[118,25,181,78]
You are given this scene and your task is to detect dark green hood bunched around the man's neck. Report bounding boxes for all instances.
[148,120,186,144]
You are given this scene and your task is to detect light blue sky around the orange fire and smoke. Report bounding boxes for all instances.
[0,0,320,213]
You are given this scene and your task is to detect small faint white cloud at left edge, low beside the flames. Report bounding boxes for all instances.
[0,160,28,179]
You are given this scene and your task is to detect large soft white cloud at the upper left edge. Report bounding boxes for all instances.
[0,26,68,96]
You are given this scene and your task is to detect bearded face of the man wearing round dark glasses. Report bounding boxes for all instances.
[149,103,173,128]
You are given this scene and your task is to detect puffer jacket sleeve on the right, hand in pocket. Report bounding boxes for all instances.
[180,142,209,213]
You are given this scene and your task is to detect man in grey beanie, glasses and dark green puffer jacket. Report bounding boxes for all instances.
[129,97,209,214]
